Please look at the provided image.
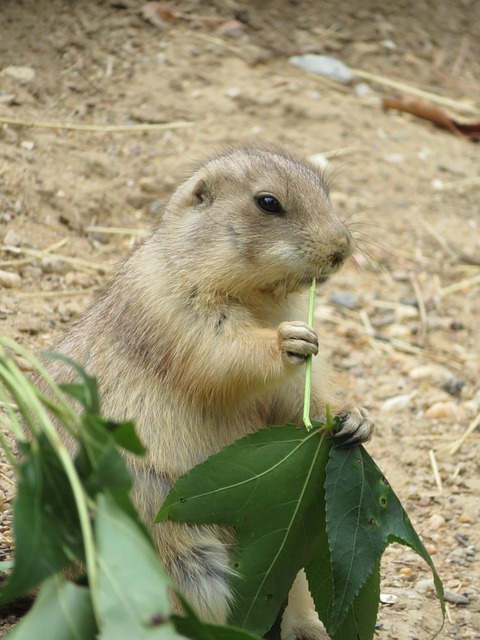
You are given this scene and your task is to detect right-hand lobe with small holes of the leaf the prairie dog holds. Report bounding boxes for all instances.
[324,447,443,639]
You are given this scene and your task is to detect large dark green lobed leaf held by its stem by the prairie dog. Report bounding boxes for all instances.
[157,423,443,640]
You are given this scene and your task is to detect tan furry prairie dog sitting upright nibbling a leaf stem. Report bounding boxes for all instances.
[49,148,373,640]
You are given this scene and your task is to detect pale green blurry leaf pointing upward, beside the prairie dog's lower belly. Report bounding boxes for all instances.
[95,495,181,640]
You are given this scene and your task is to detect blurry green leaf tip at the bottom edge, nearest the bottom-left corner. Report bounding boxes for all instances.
[8,574,97,640]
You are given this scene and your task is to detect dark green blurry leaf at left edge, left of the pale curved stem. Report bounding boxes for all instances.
[0,434,83,603]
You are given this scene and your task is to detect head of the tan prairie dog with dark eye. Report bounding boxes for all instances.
[158,148,354,296]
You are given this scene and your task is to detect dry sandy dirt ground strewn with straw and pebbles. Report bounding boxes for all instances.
[0,0,480,640]
